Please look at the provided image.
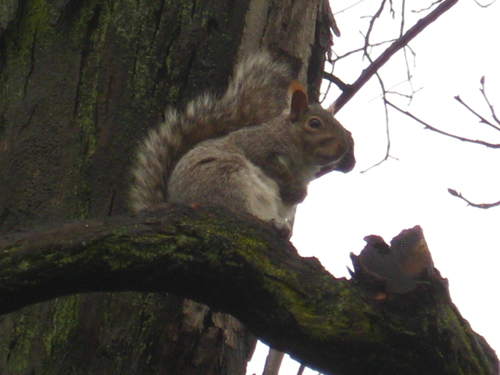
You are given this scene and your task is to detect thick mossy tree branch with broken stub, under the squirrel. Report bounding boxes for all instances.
[0,207,498,375]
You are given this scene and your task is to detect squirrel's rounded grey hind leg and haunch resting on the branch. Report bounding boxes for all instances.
[168,144,290,228]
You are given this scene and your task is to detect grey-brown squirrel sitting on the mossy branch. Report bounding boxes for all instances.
[130,52,355,229]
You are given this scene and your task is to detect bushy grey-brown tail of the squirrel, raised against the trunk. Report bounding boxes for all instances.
[130,53,292,212]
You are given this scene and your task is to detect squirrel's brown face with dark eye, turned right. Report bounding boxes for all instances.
[296,105,354,172]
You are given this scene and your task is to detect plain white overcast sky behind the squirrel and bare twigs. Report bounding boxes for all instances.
[248,0,500,375]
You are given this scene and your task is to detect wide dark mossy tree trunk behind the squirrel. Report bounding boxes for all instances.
[0,0,330,375]
